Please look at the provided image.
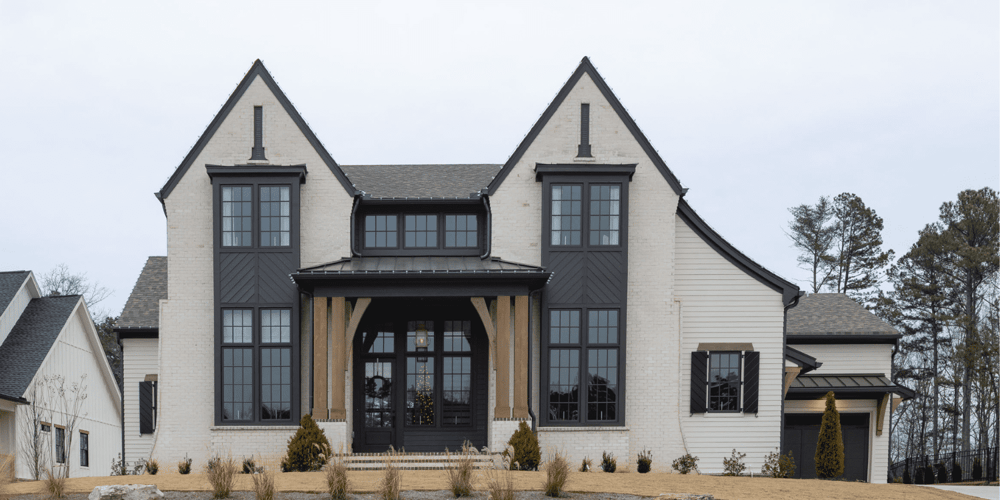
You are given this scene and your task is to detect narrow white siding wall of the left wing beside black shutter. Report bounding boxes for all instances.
[122,339,159,462]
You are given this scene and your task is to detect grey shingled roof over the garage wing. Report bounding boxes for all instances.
[786,293,899,335]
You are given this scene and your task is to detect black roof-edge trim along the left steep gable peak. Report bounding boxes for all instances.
[156,59,355,204]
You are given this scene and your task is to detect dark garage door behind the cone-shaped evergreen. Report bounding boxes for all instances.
[784,413,868,481]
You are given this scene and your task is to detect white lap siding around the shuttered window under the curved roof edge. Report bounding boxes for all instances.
[669,217,784,473]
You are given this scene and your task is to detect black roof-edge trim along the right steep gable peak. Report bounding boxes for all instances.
[489,57,685,196]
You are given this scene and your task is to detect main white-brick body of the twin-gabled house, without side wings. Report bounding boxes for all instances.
[126,58,916,481]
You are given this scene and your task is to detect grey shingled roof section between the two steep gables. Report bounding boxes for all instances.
[340,164,503,199]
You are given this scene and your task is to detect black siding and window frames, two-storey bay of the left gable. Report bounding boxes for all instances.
[208,169,306,425]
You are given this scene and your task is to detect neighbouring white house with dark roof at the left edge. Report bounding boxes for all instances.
[0,271,121,479]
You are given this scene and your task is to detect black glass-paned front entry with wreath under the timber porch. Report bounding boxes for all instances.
[354,299,489,452]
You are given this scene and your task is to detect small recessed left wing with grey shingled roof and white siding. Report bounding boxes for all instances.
[114,257,167,465]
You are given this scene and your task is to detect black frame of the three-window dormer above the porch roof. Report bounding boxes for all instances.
[351,201,489,257]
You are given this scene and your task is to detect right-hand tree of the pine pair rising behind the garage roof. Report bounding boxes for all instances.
[831,193,894,307]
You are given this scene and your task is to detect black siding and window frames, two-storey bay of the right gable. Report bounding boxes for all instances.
[535,168,635,426]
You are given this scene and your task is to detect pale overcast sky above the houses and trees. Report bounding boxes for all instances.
[0,0,1000,315]
